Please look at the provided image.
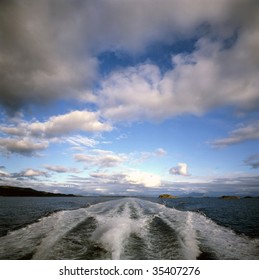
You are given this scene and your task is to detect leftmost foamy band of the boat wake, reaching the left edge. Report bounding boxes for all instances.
[0,209,89,259]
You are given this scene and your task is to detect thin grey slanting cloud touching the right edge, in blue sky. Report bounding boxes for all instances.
[212,121,259,148]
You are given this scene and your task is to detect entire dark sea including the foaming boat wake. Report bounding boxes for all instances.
[0,197,259,260]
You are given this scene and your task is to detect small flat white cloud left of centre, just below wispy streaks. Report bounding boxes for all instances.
[74,150,127,168]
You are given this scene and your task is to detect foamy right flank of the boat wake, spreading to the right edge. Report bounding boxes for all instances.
[145,199,259,259]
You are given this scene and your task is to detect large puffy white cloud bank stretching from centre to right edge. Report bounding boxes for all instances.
[96,30,259,121]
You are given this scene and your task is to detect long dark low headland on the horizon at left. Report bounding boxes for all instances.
[0,186,77,197]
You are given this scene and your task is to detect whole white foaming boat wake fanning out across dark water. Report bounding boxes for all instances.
[0,198,259,259]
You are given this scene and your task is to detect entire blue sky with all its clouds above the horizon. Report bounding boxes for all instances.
[0,0,259,196]
